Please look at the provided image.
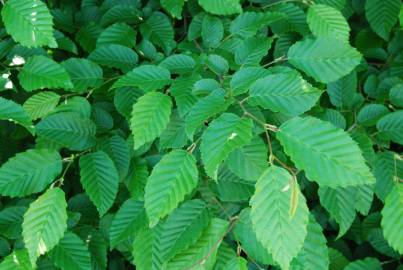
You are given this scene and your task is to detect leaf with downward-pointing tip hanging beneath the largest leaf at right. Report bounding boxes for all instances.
[318,187,355,237]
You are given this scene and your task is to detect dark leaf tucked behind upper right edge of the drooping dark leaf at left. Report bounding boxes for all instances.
[99,135,130,179]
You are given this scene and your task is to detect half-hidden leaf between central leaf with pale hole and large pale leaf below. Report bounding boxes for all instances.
[225,137,268,182]
